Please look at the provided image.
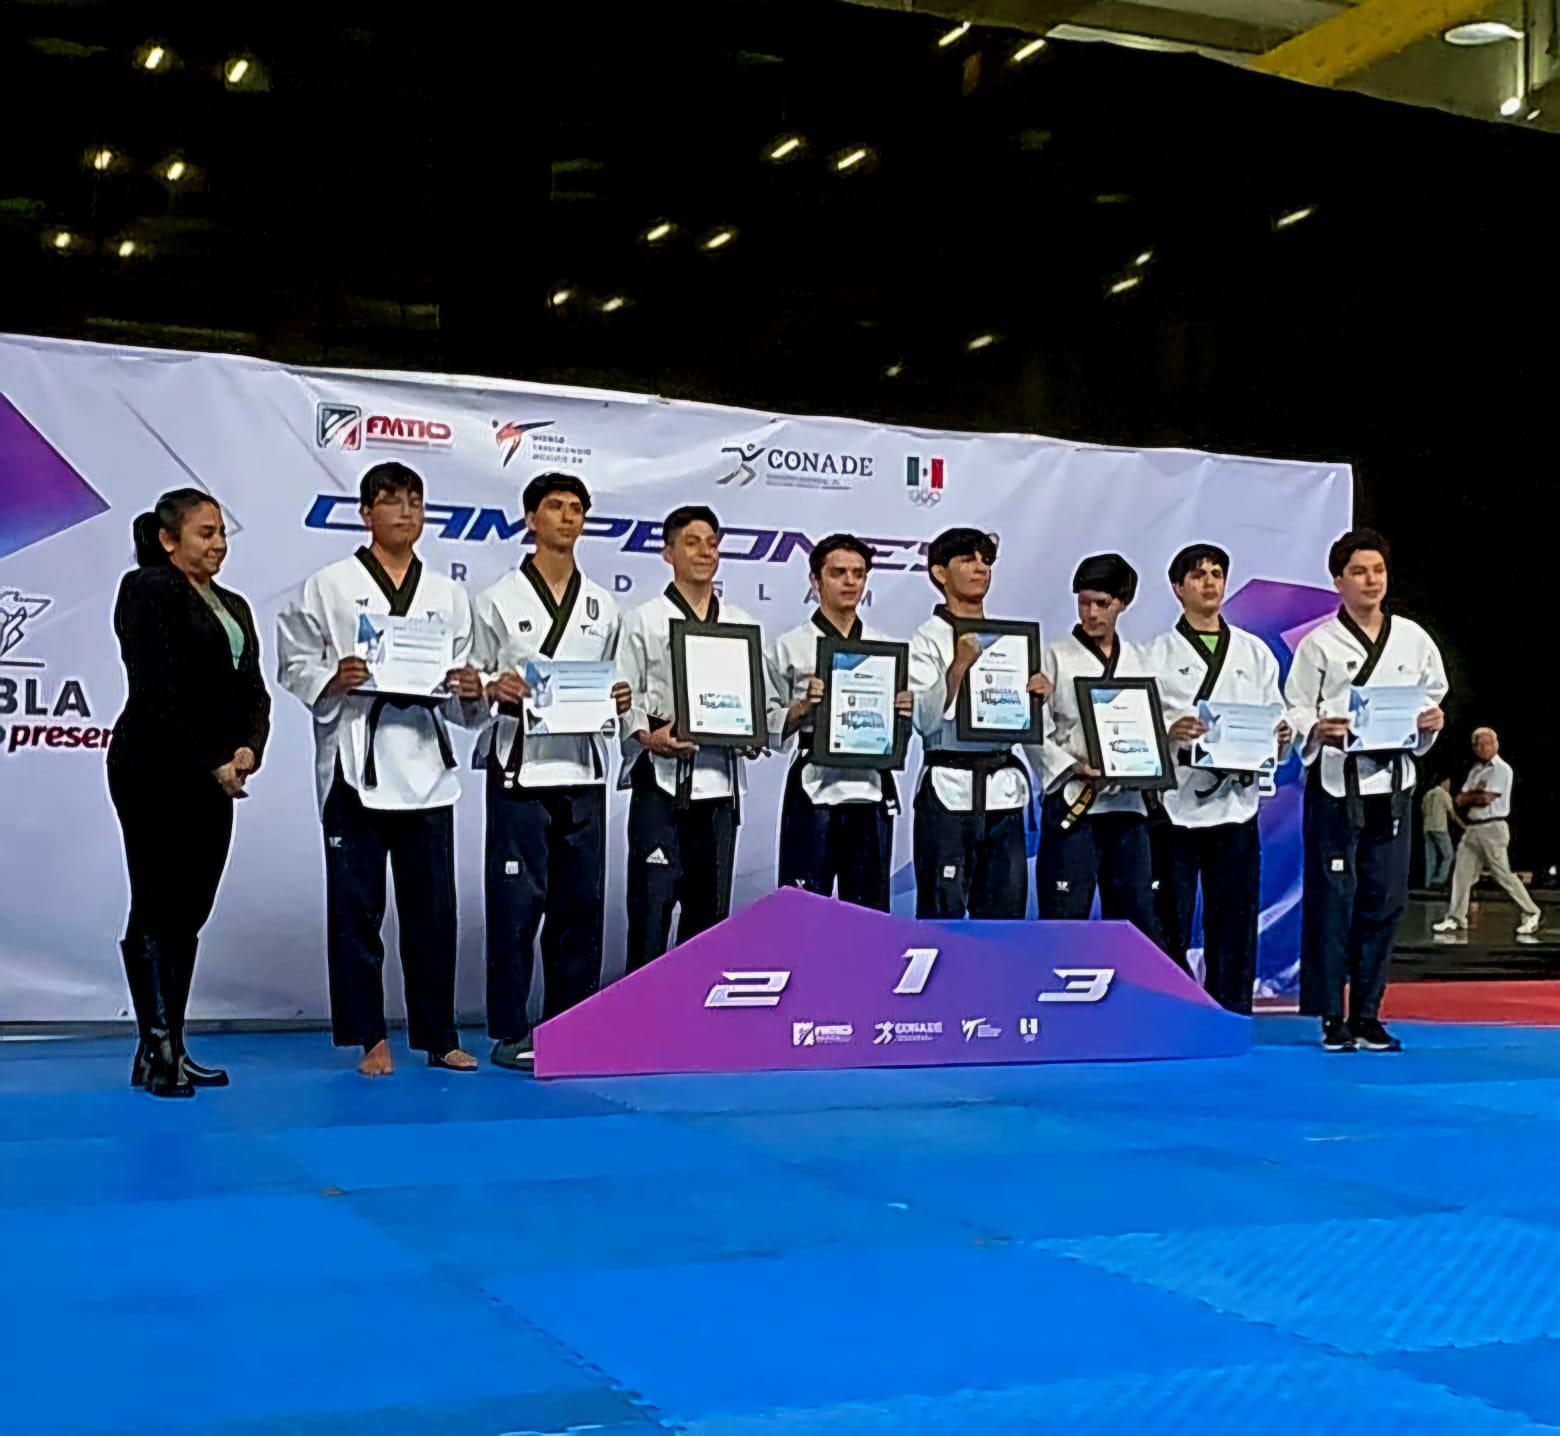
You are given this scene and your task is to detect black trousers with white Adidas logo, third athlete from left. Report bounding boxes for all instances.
[627,758,736,973]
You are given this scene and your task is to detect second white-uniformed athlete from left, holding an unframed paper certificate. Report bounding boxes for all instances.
[474,474,629,1068]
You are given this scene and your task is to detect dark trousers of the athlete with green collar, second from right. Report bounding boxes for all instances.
[1156,817,1262,1013]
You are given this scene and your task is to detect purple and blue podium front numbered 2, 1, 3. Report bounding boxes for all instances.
[535,889,1251,1077]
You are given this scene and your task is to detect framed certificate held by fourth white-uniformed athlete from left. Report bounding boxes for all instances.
[813,638,909,769]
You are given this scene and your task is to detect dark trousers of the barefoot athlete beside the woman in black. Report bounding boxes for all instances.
[324,773,457,1052]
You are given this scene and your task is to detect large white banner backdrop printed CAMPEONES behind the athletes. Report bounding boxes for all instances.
[0,337,1351,1020]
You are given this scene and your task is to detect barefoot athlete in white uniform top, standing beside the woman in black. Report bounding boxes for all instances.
[278,463,487,1077]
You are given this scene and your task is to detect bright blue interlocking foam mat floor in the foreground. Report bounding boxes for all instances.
[9,1018,1560,1436]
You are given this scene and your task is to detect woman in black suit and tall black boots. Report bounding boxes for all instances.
[108,488,271,1098]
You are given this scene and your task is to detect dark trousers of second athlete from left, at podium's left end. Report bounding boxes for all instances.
[484,762,607,1042]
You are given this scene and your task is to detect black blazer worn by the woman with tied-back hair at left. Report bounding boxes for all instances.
[109,564,271,776]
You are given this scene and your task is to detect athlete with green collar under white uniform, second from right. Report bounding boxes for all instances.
[1148,544,1290,1013]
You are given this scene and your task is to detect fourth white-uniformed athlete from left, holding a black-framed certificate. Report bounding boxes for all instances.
[766,533,911,912]
